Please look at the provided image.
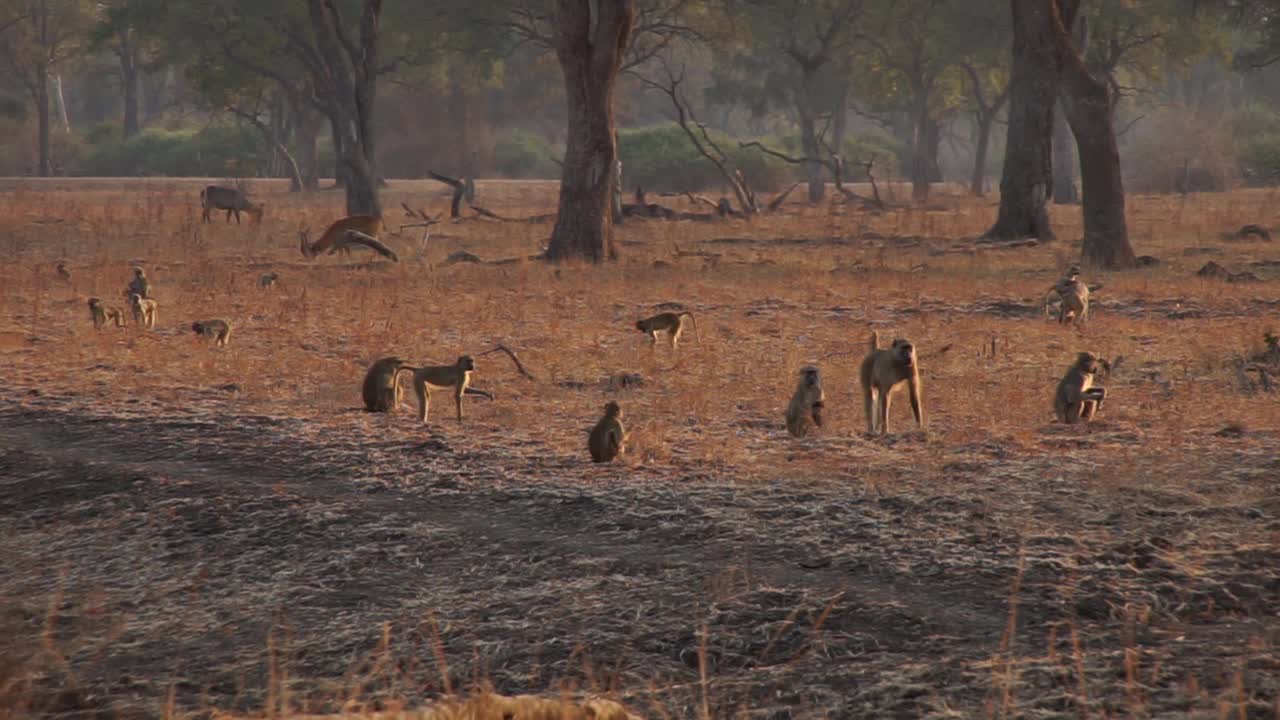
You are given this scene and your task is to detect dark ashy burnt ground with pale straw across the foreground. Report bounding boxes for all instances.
[0,386,1280,717]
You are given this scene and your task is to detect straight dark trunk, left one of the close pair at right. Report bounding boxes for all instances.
[987,0,1061,240]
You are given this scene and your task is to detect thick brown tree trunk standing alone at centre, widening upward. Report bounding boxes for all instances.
[547,0,635,263]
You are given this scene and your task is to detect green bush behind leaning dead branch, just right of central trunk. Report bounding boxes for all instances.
[618,123,795,192]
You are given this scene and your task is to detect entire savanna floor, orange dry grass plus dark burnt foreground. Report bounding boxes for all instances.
[0,175,1280,719]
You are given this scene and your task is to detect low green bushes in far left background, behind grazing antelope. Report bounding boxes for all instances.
[84,126,270,177]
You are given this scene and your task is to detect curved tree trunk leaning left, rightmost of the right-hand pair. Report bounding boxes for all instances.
[1050,15,1135,269]
